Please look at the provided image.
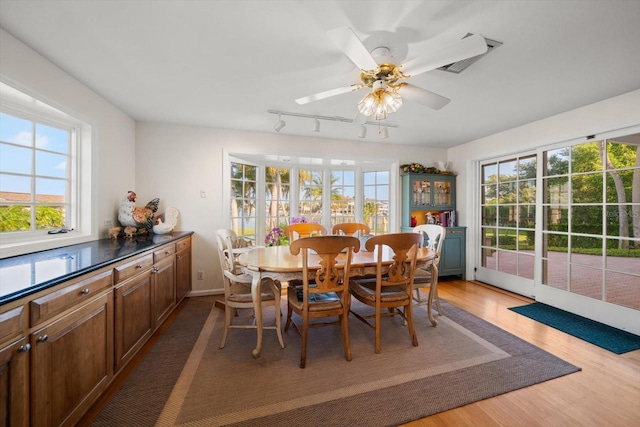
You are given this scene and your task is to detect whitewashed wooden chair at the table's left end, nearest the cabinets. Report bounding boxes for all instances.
[218,232,284,348]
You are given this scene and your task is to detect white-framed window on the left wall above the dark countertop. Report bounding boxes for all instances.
[0,82,92,257]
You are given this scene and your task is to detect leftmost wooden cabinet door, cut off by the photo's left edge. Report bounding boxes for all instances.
[0,338,31,427]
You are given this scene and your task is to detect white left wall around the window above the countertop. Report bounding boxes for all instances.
[0,29,136,256]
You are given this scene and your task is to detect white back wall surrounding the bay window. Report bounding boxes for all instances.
[135,123,446,295]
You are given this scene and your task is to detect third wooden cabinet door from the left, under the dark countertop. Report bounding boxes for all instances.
[115,269,154,372]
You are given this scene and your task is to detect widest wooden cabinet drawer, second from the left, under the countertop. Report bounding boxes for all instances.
[30,270,113,326]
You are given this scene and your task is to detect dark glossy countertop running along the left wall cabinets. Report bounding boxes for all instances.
[0,231,193,306]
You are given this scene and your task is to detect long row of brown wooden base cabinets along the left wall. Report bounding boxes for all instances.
[0,236,191,427]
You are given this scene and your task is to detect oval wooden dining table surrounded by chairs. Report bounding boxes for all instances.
[237,246,437,358]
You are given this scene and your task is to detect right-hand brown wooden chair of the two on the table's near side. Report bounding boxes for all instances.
[349,233,422,353]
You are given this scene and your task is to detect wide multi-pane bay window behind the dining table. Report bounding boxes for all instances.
[228,156,397,245]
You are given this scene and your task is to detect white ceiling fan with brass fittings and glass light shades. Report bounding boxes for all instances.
[295,27,487,120]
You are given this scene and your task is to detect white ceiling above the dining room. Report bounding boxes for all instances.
[0,0,640,148]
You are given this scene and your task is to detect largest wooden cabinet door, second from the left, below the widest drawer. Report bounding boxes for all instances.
[30,292,114,426]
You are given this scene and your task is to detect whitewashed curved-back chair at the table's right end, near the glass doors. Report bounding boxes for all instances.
[413,224,447,326]
